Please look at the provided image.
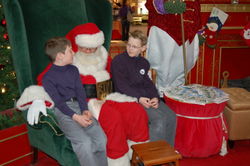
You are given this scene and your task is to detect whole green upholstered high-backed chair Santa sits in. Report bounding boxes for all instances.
[2,0,112,166]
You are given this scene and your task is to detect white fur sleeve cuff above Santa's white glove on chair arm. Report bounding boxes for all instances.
[16,85,54,110]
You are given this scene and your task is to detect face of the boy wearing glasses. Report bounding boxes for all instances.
[127,37,146,57]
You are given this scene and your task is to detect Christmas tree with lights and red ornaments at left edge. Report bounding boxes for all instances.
[0,0,19,111]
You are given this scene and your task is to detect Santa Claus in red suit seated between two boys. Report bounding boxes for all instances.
[17,23,149,166]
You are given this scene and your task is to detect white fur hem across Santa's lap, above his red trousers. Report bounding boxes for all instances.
[106,92,138,103]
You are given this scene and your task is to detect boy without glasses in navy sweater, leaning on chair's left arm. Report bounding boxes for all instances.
[42,37,107,166]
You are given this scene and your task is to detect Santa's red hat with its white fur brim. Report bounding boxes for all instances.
[66,23,104,52]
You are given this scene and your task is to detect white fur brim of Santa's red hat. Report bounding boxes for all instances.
[75,31,104,48]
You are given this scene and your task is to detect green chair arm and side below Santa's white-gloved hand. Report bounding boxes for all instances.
[23,109,80,166]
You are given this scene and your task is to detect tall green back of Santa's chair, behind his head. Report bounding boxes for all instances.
[3,0,112,93]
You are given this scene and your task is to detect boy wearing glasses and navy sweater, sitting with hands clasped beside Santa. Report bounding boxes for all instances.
[111,30,176,146]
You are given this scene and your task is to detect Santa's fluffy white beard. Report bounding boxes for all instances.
[73,46,110,82]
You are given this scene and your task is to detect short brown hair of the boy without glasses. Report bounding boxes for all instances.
[45,37,71,62]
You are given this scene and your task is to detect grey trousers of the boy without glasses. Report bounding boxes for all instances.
[55,101,108,166]
